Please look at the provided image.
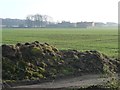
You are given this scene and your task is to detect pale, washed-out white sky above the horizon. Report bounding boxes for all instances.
[0,0,119,22]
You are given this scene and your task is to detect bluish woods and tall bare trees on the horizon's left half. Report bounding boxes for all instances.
[0,14,52,28]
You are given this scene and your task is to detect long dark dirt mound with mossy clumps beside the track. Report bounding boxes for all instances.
[2,41,120,81]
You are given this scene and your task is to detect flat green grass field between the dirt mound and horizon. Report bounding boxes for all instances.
[2,28,118,57]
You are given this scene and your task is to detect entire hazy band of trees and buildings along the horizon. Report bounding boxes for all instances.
[0,14,117,28]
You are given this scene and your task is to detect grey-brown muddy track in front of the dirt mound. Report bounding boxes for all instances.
[12,74,118,88]
